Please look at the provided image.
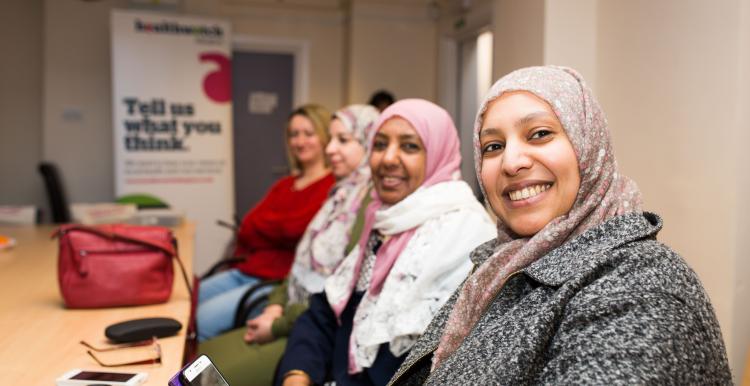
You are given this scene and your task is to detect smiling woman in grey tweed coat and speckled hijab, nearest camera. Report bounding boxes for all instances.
[391,66,732,385]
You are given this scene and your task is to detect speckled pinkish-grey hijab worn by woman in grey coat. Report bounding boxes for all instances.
[432,66,641,369]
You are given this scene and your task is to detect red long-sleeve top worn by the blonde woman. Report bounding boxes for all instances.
[234,173,336,279]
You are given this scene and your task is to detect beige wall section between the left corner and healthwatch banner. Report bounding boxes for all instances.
[42,0,125,208]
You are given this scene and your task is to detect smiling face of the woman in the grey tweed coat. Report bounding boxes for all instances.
[479,91,581,236]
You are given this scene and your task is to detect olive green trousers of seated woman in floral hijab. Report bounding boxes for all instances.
[198,327,286,386]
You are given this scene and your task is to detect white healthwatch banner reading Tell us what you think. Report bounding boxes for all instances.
[111,10,234,272]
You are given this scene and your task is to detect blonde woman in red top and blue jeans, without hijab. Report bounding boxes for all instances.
[197,105,335,341]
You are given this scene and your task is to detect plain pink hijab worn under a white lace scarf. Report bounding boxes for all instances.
[331,99,461,317]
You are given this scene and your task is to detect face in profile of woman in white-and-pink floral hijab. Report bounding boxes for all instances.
[326,119,365,178]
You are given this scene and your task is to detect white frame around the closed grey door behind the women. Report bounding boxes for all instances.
[232,34,310,108]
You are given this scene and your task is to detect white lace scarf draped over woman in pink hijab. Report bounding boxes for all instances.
[325,181,495,373]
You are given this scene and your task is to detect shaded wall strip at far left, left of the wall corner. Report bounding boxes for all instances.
[0,0,45,211]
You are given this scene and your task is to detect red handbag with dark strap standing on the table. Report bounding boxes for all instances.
[53,224,192,308]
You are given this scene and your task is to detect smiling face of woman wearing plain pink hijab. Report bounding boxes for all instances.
[370,117,427,205]
